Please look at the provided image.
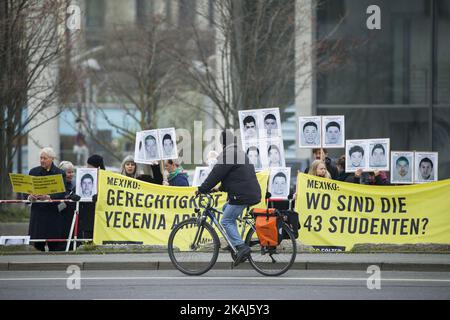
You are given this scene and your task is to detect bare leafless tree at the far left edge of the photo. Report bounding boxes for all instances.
[0,0,75,198]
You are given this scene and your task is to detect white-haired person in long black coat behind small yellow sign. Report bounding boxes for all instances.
[28,148,65,251]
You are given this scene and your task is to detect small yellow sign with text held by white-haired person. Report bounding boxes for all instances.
[9,173,66,195]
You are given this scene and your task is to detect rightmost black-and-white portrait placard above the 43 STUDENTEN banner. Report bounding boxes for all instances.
[414,152,438,183]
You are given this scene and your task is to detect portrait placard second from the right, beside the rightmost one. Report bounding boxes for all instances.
[391,151,414,184]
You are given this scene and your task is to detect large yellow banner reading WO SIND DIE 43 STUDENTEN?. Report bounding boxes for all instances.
[295,173,450,251]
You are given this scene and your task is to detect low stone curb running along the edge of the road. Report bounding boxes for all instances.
[0,261,450,272]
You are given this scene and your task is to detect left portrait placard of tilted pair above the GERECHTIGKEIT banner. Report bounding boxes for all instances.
[134,130,161,164]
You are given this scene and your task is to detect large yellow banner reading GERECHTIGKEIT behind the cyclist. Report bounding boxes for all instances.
[94,170,269,245]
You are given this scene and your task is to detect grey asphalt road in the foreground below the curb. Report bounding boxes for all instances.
[0,270,450,300]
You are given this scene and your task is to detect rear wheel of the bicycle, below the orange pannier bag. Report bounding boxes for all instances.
[245,223,297,276]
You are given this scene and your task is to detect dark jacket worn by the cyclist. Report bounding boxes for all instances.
[198,144,261,205]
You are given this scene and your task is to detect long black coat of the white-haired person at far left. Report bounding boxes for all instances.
[28,163,66,239]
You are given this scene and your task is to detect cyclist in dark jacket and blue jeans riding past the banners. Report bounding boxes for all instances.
[198,130,261,266]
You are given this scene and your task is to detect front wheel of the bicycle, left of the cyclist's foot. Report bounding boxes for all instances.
[168,218,220,276]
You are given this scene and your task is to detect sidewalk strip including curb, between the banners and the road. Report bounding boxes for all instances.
[0,252,450,272]
